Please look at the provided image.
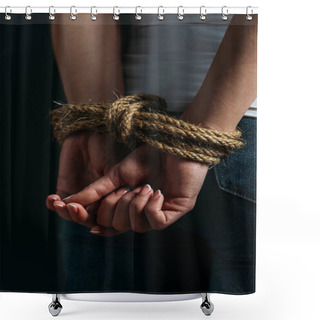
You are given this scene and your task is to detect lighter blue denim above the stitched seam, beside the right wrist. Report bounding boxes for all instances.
[214,117,257,202]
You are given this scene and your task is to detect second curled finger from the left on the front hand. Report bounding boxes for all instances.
[112,191,136,232]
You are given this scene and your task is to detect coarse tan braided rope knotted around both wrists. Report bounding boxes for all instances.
[51,94,244,165]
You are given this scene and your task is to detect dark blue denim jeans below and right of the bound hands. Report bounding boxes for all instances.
[59,117,256,294]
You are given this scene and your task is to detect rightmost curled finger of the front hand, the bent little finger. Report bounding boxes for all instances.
[144,190,183,230]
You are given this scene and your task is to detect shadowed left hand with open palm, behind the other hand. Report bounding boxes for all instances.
[46,132,128,225]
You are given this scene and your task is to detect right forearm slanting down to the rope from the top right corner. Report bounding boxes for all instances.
[182,15,257,131]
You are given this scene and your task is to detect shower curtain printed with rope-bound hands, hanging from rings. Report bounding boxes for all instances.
[0,9,257,294]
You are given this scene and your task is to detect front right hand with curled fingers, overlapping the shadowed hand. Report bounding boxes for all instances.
[61,145,208,235]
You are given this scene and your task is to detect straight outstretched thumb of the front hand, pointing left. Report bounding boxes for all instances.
[62,167,120,207]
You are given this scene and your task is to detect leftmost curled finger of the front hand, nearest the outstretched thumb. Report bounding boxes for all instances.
[97,187,130,227]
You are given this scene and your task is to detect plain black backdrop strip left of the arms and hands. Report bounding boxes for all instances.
[0,15,63,292]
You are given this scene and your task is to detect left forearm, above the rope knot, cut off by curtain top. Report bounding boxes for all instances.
[52,15,124,103]
